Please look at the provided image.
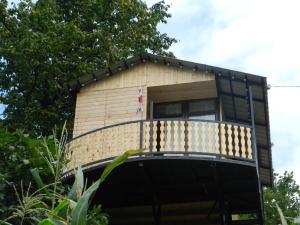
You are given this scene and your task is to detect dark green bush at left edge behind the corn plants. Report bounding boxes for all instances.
[0,123,53,219]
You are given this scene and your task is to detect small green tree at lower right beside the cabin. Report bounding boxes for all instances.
[264,171,300,225]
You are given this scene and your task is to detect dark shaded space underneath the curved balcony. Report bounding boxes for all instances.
[85,155,259,225]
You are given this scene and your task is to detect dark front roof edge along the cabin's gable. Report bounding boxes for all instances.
[65,53,265,91]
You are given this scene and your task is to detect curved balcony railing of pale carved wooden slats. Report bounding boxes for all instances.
[67,119,253,171]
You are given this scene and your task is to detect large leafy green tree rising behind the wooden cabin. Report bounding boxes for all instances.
[0,0,176,135]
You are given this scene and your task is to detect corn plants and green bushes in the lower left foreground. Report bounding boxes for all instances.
[0,123,141,225]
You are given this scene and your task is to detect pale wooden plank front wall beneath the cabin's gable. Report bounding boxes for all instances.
[73,62,215,137]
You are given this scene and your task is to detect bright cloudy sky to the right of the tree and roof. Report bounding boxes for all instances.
[146,0,300,184]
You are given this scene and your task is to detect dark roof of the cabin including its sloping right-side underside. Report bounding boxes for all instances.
[67,53,273,186]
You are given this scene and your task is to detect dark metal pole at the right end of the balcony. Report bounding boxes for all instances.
[249,86,264,225]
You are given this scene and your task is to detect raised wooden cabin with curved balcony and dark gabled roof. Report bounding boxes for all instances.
[65,53,273,225]
